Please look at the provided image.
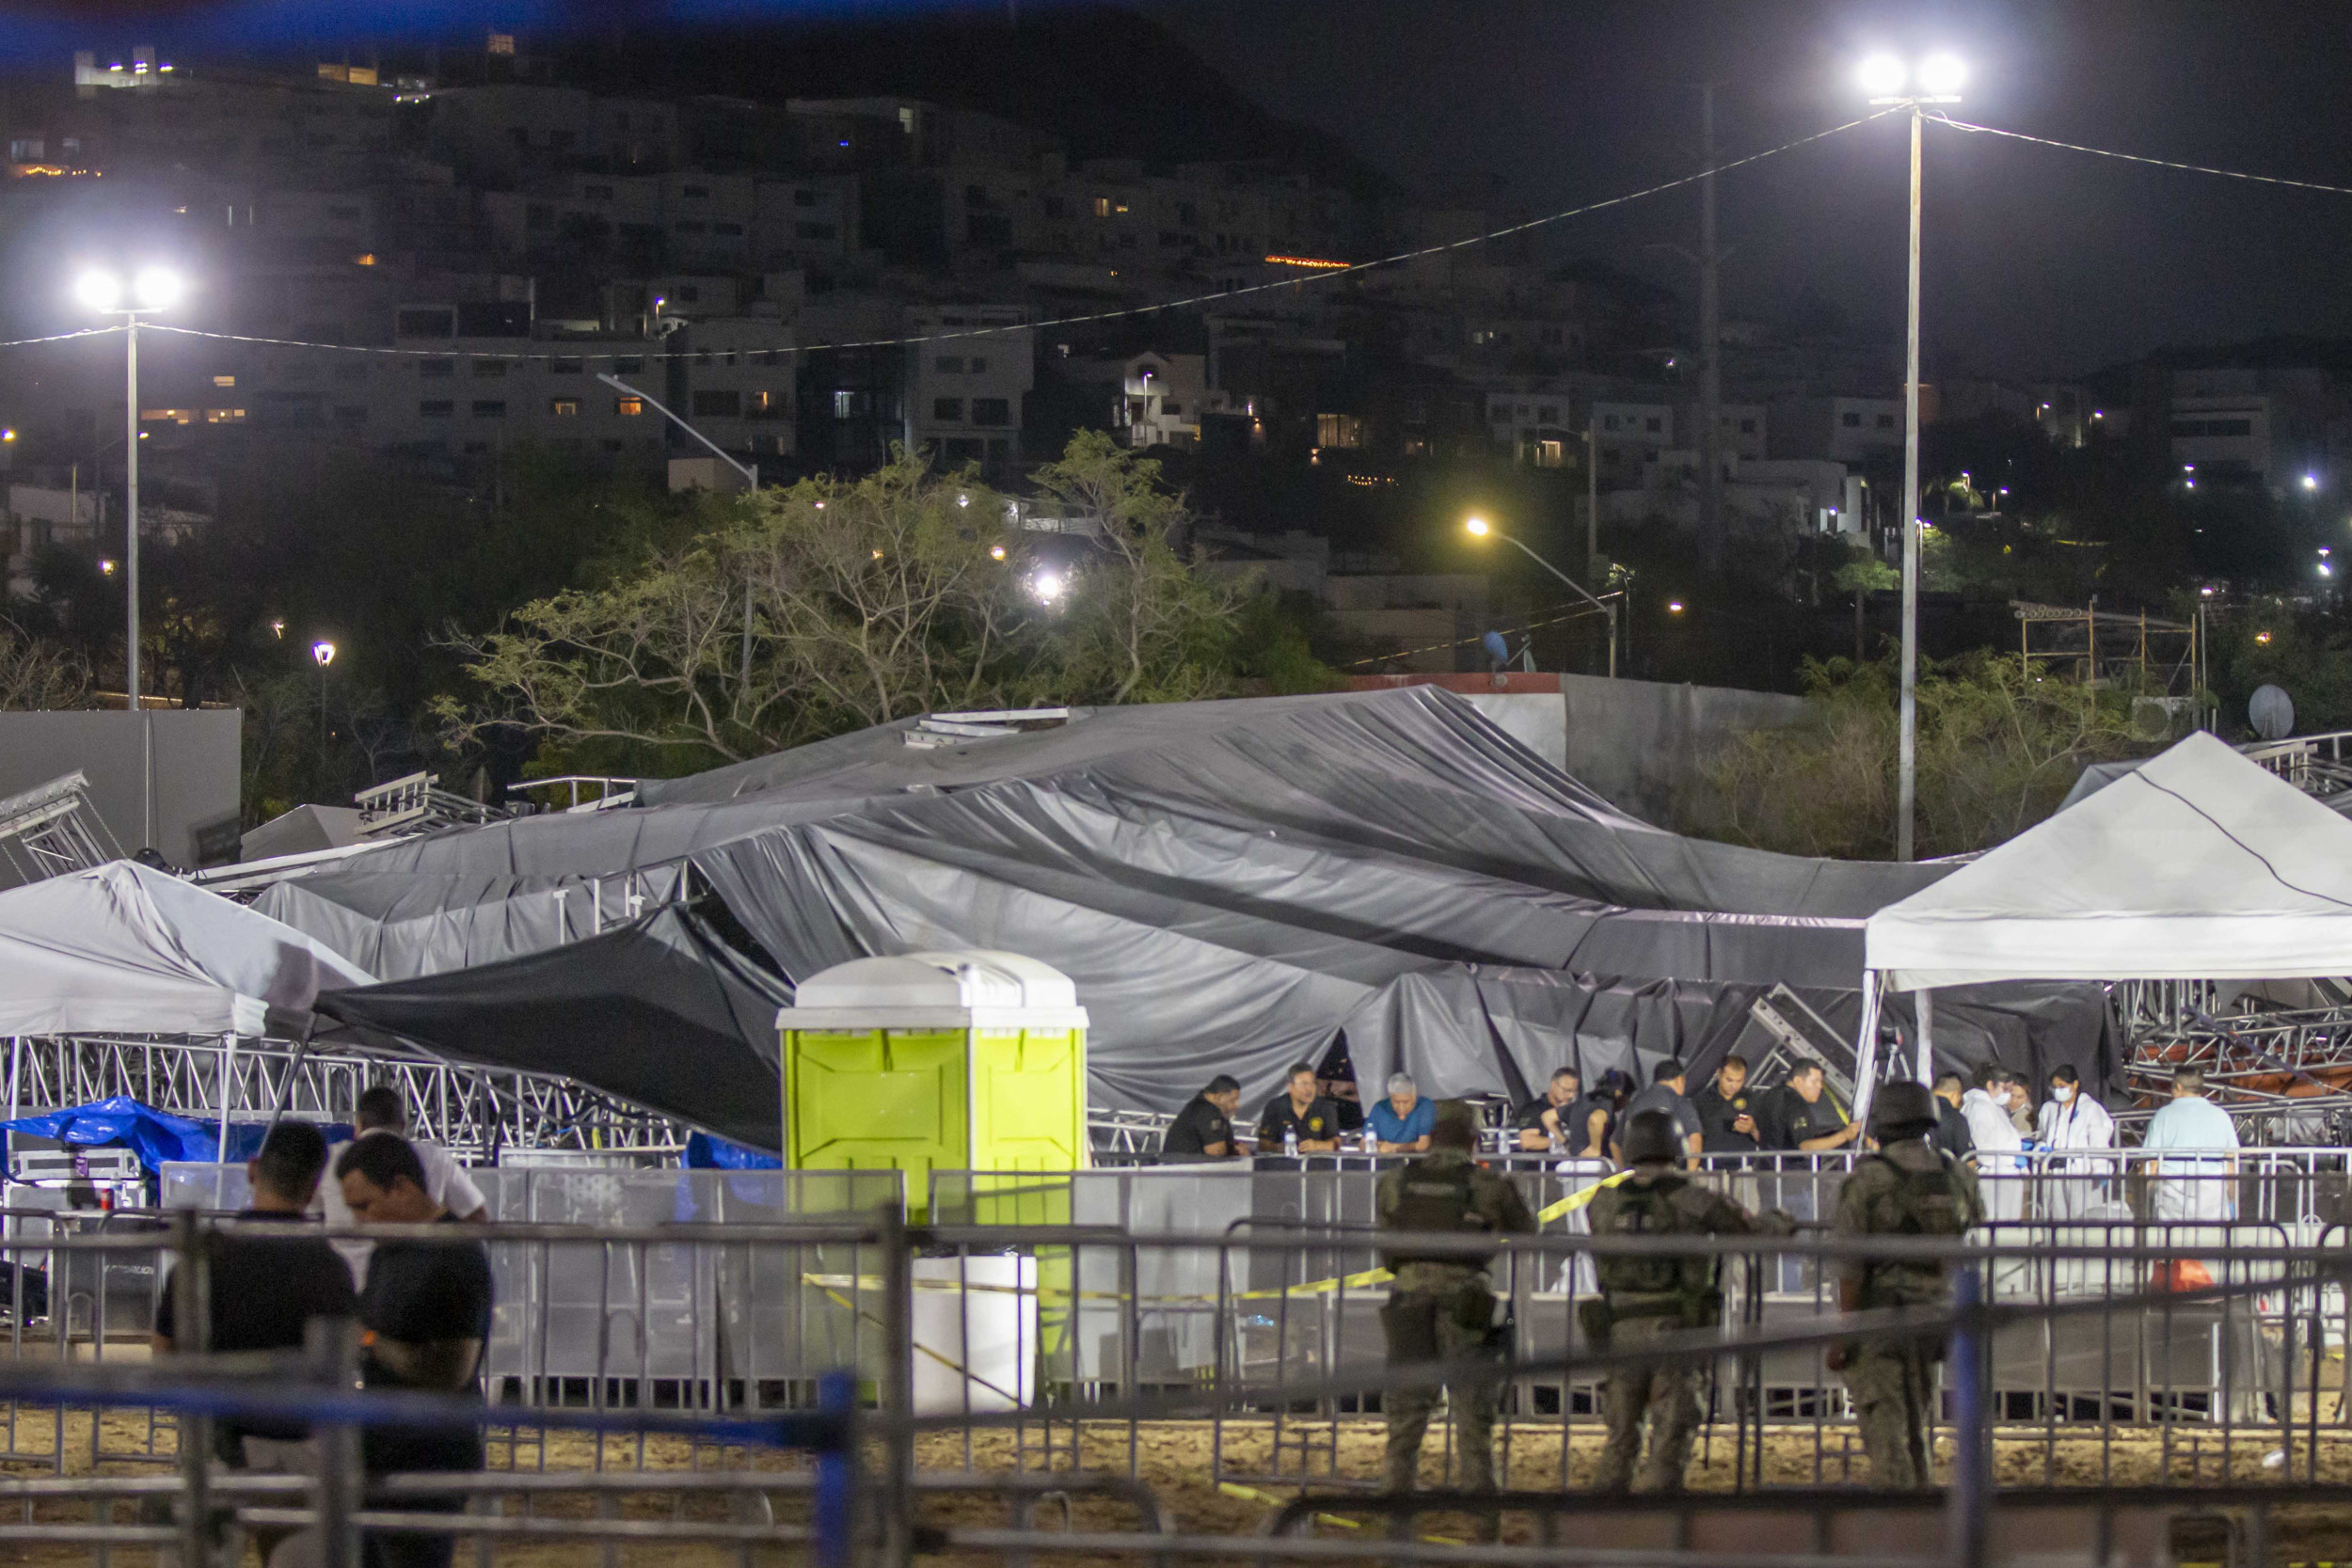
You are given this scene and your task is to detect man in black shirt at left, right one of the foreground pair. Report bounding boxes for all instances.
[334,1133,492,1568]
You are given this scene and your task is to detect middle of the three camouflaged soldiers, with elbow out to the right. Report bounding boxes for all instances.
[1579,1110,1790,1493]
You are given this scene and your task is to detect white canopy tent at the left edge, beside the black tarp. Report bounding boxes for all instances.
[0,861,374,1143]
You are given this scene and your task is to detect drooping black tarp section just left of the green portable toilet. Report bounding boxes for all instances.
[318,905,793,1149]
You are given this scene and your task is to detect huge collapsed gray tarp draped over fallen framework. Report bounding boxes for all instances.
[263,687,2098,1110]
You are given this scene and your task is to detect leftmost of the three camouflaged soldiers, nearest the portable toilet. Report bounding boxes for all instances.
[1381,1102,1536,1493]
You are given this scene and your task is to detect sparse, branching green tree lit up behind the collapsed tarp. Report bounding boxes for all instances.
[436,433,1237,776]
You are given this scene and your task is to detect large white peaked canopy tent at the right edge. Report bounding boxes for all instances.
[1853,731,2352,1117]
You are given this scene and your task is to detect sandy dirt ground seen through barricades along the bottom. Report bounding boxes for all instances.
[0,1416,2352,1568]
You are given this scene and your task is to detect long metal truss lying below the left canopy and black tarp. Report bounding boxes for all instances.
[8,1037,687,1164]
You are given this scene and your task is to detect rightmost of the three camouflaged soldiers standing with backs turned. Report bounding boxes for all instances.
[1830,1082,1985,1491]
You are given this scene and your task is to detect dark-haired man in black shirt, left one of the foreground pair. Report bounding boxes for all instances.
[155,1121,358,1561]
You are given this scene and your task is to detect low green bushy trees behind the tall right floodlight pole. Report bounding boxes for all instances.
[1696,651,2154,861]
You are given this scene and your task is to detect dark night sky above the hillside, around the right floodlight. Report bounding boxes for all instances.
[1143,0,2352,373]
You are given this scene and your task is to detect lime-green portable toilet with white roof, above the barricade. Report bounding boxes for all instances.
[776,952,1087,1213]
